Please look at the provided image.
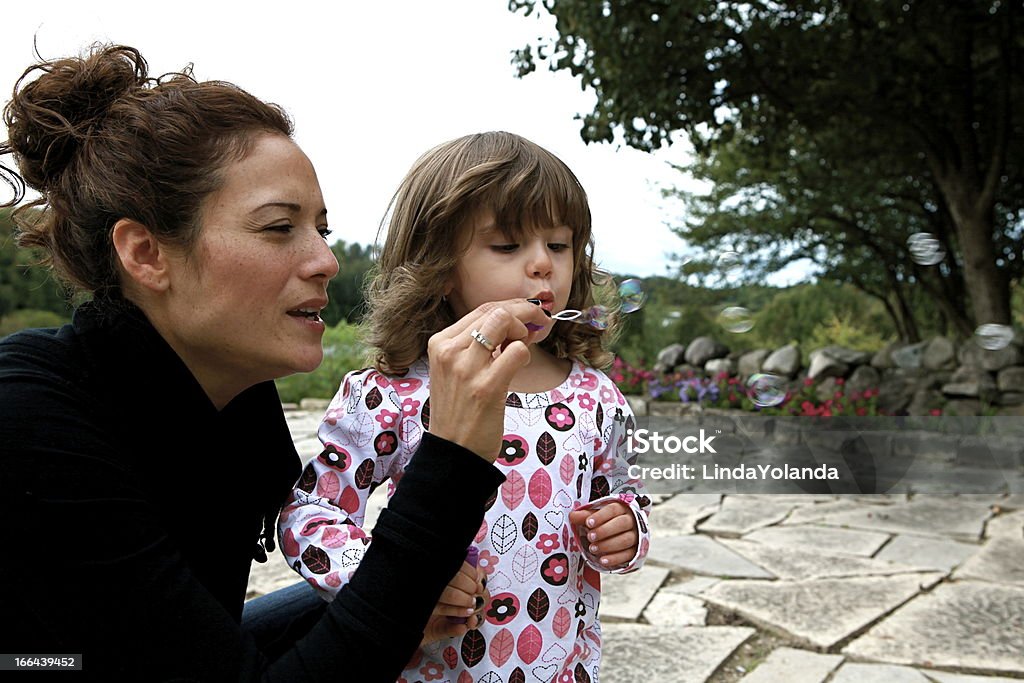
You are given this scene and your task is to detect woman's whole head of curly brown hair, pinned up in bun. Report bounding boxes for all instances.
[0,44,292,294]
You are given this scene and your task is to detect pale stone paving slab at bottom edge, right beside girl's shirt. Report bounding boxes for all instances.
[601,624,755,683]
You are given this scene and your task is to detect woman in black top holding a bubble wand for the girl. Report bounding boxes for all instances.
[0,46,546,683]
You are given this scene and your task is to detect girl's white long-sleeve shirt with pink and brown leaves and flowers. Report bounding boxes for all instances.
[280,359,650,683]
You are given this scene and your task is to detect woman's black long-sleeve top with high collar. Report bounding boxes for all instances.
[0,302,504,683]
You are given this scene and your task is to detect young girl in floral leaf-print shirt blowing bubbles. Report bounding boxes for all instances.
[280,132,650,683]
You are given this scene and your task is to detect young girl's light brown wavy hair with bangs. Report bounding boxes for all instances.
[366,132,618,374]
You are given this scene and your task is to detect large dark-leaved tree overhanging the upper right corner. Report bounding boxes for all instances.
[510,0,1024,336]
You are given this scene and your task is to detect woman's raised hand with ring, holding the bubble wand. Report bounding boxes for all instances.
[427,299,552,463]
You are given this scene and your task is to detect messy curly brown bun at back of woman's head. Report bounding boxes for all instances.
[4,45,147,191]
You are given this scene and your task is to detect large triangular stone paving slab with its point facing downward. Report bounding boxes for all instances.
[703,573,942,649]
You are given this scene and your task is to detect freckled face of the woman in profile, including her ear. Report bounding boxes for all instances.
[165,134,338,405]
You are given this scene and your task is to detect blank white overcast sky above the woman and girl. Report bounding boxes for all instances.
[0,0,716,275]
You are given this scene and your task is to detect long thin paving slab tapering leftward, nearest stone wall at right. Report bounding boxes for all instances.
[806,496,992,541]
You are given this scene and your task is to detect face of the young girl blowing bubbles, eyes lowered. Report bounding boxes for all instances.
[445,211,574,341]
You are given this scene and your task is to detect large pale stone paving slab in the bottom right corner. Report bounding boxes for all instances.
[843,582,1024,674]
